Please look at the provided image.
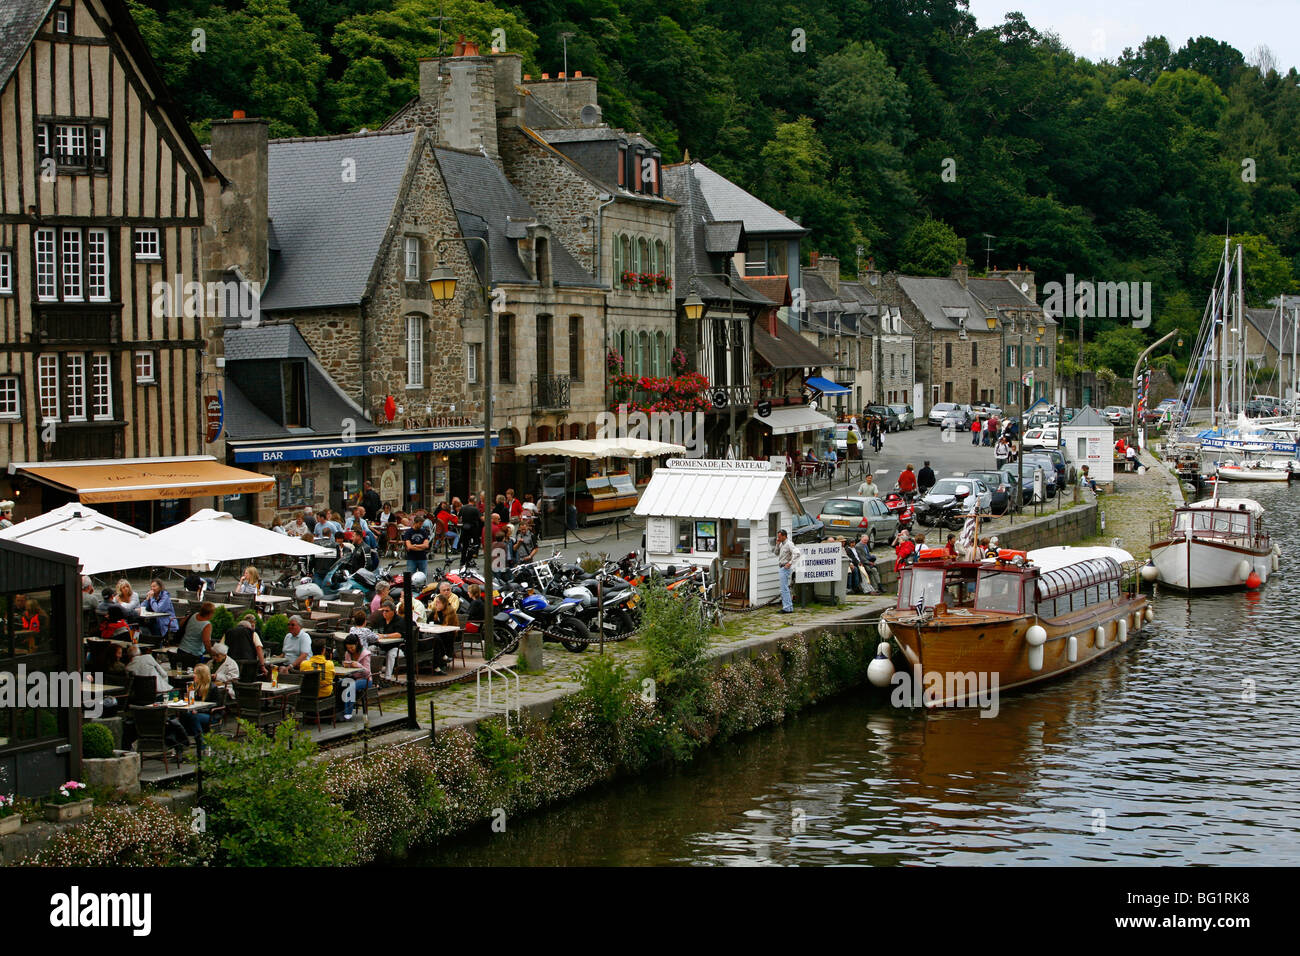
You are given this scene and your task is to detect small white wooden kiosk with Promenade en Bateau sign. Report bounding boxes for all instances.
[636,458,806,606]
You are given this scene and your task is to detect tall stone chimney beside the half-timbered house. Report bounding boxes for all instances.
[204,117,269,284]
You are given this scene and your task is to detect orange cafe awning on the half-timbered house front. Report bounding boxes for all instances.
[9,457,276,505]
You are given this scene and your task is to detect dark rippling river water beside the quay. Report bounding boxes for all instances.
[420,484,1300,866]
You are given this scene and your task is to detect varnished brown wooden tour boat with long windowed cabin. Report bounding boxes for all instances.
[872,546,1154,708]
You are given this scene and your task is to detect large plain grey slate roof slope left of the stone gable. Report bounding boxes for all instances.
[261,130,417,311]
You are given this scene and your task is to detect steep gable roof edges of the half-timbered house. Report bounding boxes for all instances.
[0,0,226,185]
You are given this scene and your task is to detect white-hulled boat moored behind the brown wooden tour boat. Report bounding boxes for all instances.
[1143,486,1278,591]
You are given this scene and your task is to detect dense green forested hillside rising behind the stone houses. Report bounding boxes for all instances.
[133,0,1300,371]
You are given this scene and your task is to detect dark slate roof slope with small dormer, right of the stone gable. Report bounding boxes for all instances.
[434,148,597,287]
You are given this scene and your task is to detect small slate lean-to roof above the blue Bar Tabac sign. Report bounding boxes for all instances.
[225,324,378,441]
